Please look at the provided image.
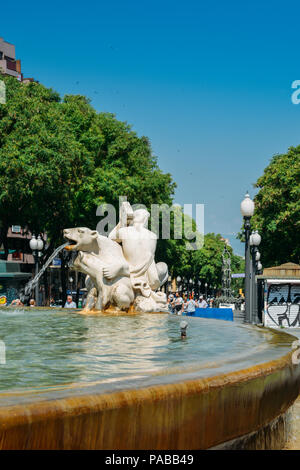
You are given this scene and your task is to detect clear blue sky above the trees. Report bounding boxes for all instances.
[0,0,300,258]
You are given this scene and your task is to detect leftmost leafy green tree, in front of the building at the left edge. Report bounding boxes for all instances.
[0,77,92,258]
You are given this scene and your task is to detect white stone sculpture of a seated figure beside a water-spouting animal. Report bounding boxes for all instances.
[64,202,168,312]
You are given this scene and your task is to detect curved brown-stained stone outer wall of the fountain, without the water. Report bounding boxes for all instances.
[0,324,300,450]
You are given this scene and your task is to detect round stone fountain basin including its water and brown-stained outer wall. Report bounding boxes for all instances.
[0,308,300,450]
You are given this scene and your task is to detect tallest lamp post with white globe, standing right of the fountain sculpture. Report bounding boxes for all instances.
[241,192,255,323]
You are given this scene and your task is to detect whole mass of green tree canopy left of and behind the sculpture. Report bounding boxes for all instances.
[0,77,175,255]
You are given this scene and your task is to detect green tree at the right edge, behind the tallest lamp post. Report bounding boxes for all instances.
[251,146,300,267]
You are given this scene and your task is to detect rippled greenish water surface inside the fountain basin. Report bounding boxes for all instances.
[0,309,265,390]
